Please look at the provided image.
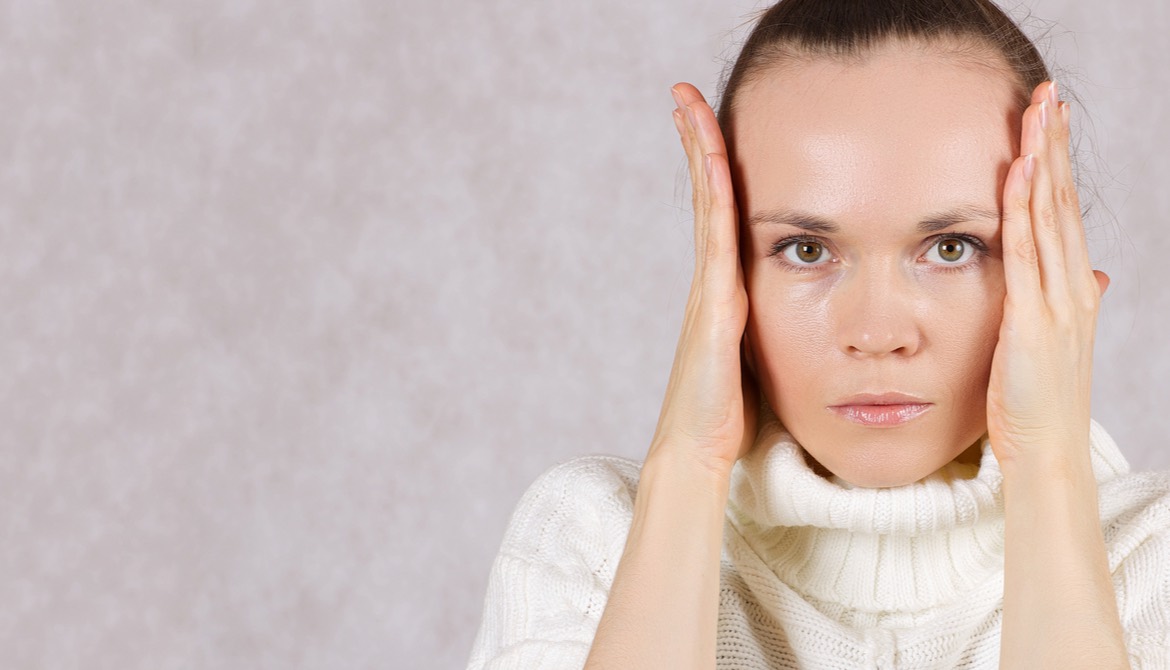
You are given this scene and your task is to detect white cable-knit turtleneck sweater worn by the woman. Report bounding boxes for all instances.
[468,413,1170,670]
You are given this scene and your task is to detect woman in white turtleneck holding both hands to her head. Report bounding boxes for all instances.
[470,0,1170,669]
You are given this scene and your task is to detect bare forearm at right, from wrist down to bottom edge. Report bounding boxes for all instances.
[999,444,1129,670]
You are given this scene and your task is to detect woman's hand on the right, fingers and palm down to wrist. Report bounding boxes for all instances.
[987,82,1109,464]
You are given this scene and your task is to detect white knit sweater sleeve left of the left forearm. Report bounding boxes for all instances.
[468,455,640,670]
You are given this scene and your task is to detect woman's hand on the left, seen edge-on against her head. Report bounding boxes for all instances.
[648,83,759,474]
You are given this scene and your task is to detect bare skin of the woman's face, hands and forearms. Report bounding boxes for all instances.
[586,36,1129,669]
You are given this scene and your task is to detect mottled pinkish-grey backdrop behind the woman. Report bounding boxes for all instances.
[0,0,1170,669]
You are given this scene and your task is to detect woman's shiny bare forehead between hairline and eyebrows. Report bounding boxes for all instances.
[731,48,1020,222]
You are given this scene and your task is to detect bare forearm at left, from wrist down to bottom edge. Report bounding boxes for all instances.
[585,444,730,670]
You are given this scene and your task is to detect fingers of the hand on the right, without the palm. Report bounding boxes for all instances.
[1004,82,1102,316]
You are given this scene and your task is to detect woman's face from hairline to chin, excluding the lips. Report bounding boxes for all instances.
[732,44,1020,488]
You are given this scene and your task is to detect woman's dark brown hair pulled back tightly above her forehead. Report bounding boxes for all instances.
[716,0,1048,137]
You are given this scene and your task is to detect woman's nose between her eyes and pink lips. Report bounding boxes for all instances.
[830,268,922,358]
